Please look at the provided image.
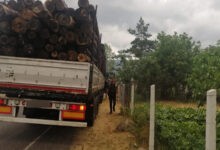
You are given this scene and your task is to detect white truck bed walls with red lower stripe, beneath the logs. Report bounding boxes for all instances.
[0,56,104,95]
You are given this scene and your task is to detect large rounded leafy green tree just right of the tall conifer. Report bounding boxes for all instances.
[155,32,200,98]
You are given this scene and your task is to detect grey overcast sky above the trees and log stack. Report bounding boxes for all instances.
[68,0,220,52]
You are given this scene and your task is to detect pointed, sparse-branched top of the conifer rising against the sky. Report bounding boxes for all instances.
[124,18,155,58]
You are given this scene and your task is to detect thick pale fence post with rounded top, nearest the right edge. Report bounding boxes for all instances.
[206,89,217,150]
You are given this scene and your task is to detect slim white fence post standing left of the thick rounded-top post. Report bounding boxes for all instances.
[149,85,155,150]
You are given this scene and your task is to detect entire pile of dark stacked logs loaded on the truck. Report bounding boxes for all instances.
[0,0,105,73]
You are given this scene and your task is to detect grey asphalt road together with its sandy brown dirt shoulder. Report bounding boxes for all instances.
[0,100,134,150]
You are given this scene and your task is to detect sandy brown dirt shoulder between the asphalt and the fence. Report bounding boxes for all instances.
[71,99,135,150]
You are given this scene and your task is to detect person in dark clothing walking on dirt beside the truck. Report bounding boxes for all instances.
[108,79,117,114]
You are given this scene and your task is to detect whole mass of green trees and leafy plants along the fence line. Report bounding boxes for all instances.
[106,18,220,150]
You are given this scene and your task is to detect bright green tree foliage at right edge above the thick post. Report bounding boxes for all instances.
[187,47,220,103]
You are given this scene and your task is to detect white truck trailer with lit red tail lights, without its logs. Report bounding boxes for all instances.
[0,56,105,127]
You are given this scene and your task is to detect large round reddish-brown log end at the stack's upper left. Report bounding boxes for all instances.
[12,17,27,33]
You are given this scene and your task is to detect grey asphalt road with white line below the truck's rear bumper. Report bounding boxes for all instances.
[0,122,82,150]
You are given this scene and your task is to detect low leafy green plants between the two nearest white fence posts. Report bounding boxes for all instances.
[156,106,205,150]
